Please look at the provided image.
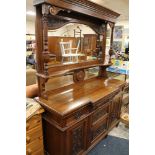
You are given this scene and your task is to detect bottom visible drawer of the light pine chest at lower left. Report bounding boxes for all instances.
[26,137,43,155]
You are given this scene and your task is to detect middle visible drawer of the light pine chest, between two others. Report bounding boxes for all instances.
[26,124,42,144]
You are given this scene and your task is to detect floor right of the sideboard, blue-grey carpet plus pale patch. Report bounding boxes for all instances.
[87,123,129,155]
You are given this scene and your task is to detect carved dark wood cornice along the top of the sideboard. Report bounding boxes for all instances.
[33,0,120,22]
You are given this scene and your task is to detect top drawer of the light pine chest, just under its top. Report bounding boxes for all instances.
[26,115,42,131]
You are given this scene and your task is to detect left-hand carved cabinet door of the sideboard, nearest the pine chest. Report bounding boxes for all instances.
[67,120,88,155]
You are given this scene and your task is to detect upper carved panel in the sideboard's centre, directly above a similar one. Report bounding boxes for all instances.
[92,103,109,123]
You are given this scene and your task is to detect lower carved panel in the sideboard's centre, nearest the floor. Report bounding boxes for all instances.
[91,117,108,141]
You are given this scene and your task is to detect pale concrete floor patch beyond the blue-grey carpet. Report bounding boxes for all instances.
[109,122,129,139]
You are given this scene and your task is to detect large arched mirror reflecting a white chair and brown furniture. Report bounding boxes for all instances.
[48,23,99,63]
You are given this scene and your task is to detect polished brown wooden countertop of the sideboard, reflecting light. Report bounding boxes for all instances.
[37,77,125,116]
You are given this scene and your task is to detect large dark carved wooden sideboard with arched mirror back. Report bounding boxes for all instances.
[34,0,125,155]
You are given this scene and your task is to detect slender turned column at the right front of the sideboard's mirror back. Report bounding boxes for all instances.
[108,22,115,63]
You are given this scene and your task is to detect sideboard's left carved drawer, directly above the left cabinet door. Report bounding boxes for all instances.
[66,107,89,126]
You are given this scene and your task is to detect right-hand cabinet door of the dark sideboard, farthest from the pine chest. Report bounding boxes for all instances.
[109,92,122,125]
